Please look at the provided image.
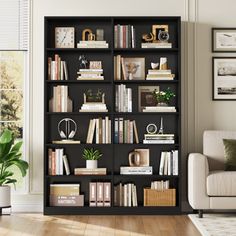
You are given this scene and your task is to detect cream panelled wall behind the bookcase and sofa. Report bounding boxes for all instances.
[18,0,236,212]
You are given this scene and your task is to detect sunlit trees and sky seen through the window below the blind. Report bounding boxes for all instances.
[0,51,24,138]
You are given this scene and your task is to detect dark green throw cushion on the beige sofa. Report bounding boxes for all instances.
[223,139,236,171]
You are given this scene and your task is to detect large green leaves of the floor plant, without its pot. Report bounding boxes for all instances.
[0,129,29,186]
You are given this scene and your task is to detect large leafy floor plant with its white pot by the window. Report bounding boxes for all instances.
[0,129,29,207]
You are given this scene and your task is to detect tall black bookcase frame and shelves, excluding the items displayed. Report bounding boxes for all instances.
[44,16,181,215]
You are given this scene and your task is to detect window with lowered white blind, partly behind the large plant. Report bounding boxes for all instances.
[0,0,29,193]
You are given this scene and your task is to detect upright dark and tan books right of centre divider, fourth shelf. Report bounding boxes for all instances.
[114,117,139,144]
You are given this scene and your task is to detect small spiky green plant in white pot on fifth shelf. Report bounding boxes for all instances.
[83,148,102,169]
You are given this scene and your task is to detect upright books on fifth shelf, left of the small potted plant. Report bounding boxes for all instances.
[48,148,70,175]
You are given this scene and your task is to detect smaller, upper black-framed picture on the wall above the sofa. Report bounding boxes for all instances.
[211,28,236,52]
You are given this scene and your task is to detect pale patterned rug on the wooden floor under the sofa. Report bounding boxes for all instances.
[188,214,236,236]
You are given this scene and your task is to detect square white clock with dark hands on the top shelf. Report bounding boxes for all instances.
[55,27,75,48]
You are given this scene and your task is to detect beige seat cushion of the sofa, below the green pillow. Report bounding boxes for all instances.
[207,171,236,196]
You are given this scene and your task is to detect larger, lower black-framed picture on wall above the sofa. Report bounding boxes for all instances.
[212,57,236,100]
